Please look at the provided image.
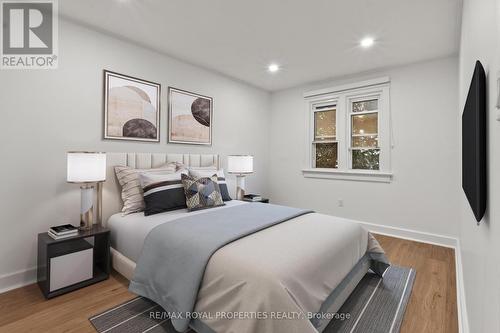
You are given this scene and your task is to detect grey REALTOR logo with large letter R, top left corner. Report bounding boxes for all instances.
[0,0,58,69]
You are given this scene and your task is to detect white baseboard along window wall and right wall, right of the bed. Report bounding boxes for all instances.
[360,222,469,333]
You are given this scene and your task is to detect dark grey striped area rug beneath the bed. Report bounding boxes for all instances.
[89,266,415,333]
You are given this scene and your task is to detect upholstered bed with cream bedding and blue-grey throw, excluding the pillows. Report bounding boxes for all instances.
[104,154,388,333]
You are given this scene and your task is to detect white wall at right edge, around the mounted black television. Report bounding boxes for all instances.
[456,0,500,332]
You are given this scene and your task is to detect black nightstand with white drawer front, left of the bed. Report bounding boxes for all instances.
[37,225,111,298]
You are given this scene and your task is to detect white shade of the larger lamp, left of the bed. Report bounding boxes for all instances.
[68,152,106,183]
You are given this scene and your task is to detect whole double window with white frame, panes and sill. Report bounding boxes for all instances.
[303,78,392,181]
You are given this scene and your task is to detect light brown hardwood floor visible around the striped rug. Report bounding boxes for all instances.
[0,235,458,333]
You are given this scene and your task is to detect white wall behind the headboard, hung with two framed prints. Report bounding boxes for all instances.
[0,21,270,291]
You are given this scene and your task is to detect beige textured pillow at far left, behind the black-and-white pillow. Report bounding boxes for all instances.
[115,163,178,215]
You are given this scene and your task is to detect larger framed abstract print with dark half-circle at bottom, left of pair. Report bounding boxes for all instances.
[104,70,161,142]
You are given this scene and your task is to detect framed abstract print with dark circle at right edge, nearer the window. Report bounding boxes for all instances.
[168,87,213,145]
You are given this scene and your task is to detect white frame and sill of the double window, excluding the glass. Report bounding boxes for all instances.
[302,77,393,182]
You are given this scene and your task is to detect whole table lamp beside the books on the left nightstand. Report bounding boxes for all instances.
[67,152,106,230]
